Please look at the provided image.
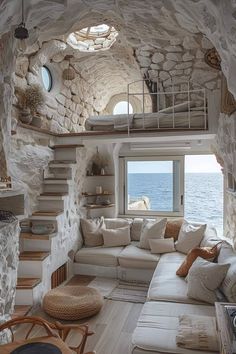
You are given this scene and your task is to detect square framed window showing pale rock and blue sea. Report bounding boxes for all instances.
[123,157,183,216]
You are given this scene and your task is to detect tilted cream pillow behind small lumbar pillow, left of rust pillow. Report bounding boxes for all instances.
[139,218,167,250]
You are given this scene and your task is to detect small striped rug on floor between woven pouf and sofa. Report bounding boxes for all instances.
[106,281,149,304]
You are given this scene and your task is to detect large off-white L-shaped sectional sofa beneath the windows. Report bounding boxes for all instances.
[75,219,236,354]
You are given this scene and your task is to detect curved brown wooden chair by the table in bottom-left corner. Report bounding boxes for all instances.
[0,316,95,354]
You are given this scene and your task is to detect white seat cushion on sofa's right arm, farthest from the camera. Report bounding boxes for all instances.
[147,252,207,304]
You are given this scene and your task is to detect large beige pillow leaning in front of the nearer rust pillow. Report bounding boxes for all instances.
[187,257,230,304]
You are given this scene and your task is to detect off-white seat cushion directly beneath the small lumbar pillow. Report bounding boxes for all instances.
[118,242,160,269]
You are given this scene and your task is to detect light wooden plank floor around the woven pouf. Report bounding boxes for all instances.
[18,275,143,354]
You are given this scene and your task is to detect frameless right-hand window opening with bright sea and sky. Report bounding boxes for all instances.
[184,155,223,235]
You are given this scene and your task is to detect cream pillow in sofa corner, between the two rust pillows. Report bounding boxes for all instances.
[176,220,206,254]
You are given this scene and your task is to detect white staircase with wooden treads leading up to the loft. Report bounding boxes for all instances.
[15,144,83,314]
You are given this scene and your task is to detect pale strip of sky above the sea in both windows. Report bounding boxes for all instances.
[128,155,221,173]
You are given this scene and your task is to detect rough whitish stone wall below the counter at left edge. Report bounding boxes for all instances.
[0,221,20,343]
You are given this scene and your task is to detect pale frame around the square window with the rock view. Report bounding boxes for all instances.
[119,155,184,217]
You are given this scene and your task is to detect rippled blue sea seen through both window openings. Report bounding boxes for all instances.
[128,173,223,235]
